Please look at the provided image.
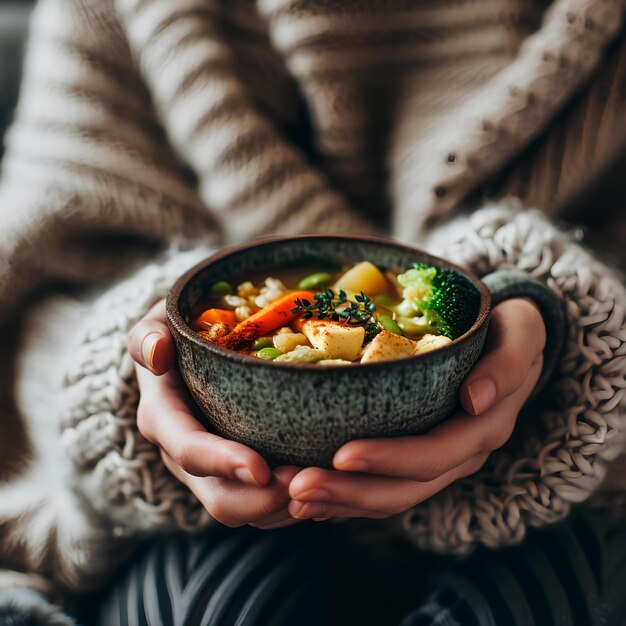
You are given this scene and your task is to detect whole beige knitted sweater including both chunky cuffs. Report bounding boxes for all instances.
[0,0,626,589]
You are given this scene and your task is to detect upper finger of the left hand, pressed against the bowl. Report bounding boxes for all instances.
[137,367,270,486]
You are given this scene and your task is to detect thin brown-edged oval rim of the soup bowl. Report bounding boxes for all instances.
[165,233,491,372]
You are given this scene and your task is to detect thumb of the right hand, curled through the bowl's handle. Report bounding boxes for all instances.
[460,298,546,415]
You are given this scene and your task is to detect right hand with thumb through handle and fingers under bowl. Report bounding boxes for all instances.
[289,299,546,520]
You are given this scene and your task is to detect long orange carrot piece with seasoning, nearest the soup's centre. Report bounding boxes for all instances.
[219,291,315,350]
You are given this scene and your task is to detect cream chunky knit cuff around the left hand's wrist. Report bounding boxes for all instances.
[61,248,216,536]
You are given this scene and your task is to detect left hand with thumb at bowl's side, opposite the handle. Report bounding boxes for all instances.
[128,301,300,529]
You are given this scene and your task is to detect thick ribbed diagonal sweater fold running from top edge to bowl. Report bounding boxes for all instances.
[115,0,373,242]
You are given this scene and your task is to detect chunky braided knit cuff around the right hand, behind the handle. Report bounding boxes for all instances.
[402,207,626,554]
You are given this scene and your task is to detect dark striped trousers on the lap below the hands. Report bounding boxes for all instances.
[91,504,626,626]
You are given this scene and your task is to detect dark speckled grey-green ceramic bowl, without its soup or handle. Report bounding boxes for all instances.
[167,235,544,466]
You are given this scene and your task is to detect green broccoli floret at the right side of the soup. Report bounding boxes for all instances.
[396,263,480,339]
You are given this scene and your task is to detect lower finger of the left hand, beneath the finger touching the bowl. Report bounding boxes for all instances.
[173,466,300,528]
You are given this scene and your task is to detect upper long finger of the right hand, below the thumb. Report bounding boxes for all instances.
[332,360,541,478]
